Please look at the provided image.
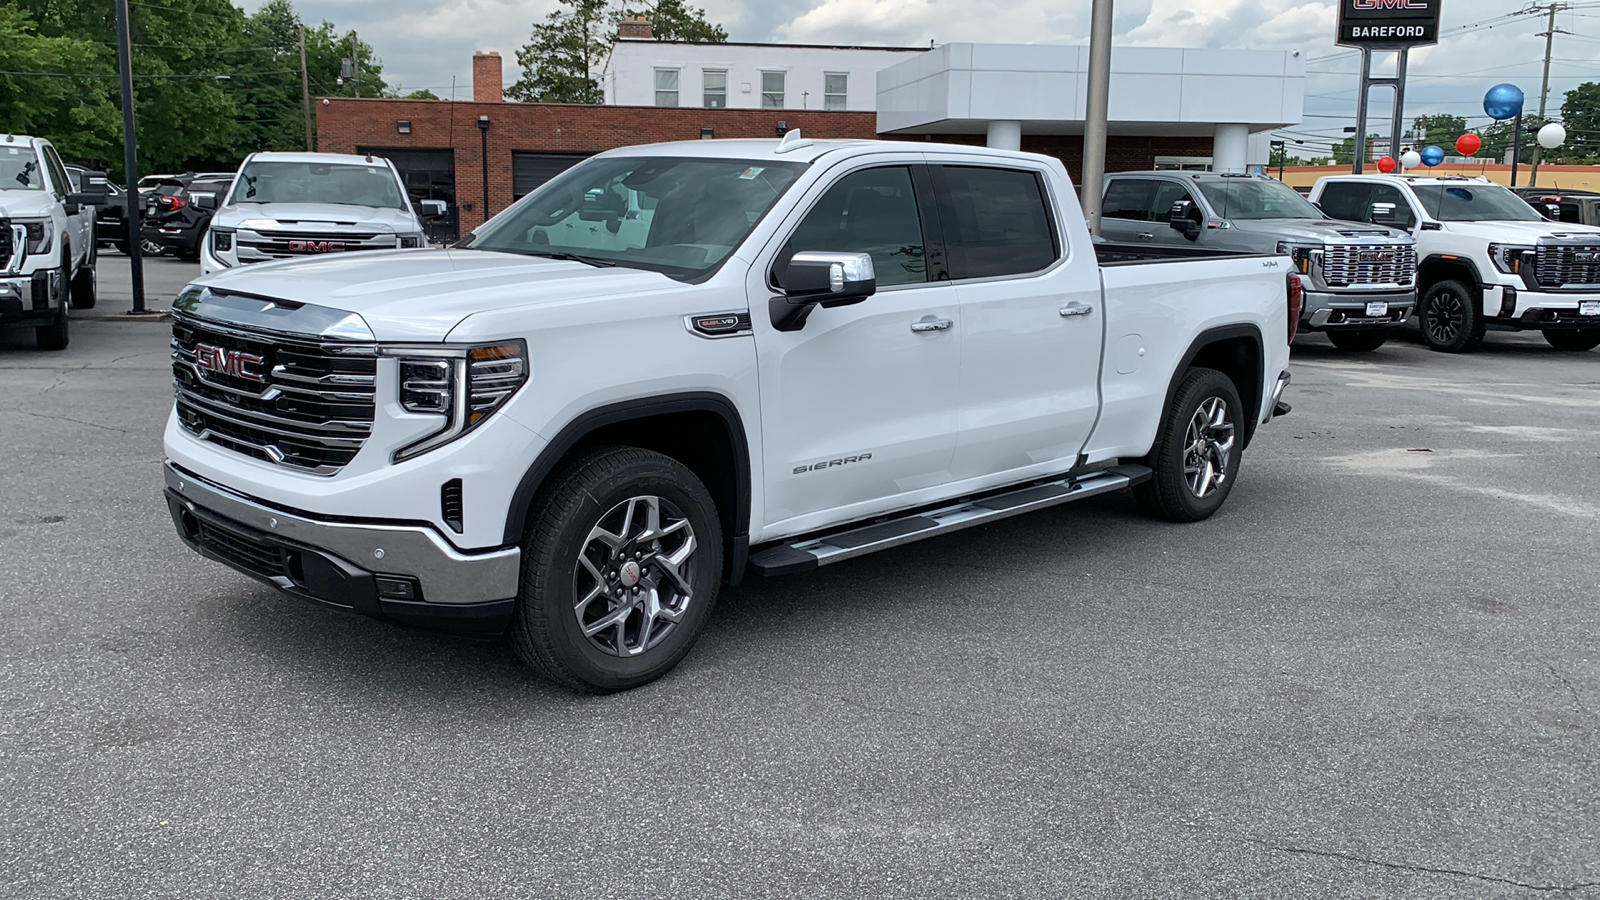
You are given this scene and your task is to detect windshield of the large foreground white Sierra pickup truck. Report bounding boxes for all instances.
[467,157,805,279]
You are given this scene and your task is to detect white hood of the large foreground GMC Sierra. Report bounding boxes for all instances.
[195,250,682,341]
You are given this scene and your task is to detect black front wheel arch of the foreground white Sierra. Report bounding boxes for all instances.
[504,392,750,585]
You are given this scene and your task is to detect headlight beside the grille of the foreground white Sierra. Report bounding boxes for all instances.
[382,341,528,463]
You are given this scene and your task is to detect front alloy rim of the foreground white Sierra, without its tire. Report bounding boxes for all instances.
[573,496,696,657]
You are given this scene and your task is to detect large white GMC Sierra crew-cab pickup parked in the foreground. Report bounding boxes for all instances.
[165,131,1301,690]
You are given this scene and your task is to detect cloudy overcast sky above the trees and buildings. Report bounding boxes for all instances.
[243,0,1600,156]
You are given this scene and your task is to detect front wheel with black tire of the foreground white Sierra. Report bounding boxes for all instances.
[510,447,722,693]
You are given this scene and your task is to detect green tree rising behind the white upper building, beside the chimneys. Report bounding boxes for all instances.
[506,0,728,102]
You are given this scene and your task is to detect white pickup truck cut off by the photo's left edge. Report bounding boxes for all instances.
[0,135,106,351]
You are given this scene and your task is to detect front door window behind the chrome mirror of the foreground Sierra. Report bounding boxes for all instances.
[773,167,928,287]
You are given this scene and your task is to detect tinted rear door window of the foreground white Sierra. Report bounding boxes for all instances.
[933,165,1059,279]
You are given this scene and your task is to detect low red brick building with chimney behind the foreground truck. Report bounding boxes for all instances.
[317,53,1211,240]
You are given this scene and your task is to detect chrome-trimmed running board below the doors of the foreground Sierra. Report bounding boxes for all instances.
[750,466,1150,575]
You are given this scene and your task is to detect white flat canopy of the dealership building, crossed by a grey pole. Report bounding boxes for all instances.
[878,43,1306,136]
